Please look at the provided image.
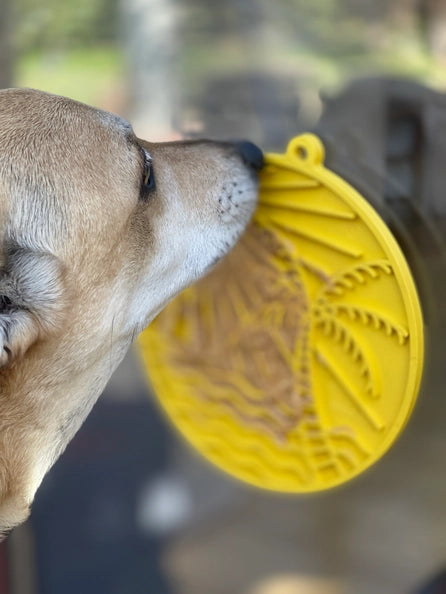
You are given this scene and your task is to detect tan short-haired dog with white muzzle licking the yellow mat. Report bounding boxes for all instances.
[0,89,262,535]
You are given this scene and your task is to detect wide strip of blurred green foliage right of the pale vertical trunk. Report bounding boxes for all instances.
[178,0,446,89]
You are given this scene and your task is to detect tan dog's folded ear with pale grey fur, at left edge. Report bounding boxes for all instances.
[0,247,66,367]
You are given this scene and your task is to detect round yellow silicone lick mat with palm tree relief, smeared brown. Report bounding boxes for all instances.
[139,134,423,493]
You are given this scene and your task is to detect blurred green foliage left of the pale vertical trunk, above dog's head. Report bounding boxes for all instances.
[13,0,124,105]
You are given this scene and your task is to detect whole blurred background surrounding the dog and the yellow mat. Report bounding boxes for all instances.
[0,0,446,594]
